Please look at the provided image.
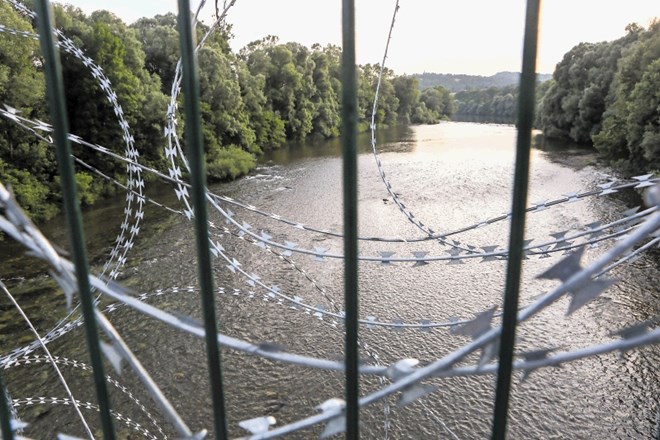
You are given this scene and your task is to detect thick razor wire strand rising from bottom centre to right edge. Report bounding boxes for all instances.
[236,198,660,439]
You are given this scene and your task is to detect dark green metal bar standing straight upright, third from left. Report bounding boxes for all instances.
[341,0,360,439]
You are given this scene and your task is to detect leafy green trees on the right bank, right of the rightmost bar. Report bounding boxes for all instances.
[537,20,660,174]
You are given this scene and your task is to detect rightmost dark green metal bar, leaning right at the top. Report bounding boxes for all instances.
[492,0,540,440]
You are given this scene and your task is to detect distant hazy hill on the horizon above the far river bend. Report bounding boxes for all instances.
[412,72,552,92]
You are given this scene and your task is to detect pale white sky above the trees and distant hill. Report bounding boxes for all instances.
[50,0,660,75]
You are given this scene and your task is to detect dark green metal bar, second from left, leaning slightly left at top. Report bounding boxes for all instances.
[179,0,227,440]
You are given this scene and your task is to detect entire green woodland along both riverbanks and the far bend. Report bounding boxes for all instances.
[0,2,660,221]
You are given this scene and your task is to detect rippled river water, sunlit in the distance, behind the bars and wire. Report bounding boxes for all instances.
[0,122,660,439]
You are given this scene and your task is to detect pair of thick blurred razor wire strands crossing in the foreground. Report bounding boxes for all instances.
[0,175,660,438]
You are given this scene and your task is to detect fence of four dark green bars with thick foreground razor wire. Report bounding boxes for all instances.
[0,0,660,439]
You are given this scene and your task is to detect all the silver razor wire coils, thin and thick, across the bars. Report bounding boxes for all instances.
[0,0,660,438]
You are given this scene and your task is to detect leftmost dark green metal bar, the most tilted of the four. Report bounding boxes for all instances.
[34,0,115,440]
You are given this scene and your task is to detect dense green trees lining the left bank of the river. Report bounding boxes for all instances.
[0,2,453,221]
